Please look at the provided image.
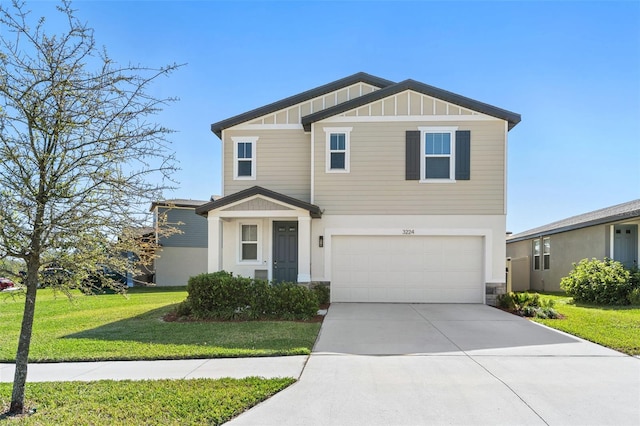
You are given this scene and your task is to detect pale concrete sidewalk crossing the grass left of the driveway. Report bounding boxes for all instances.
[0,355,308,382]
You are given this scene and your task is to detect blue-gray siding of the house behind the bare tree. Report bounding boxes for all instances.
[158,207,208,248]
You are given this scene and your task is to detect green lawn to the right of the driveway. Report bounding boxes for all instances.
[535,294,640,355]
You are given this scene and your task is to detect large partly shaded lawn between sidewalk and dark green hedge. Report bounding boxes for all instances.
[0,287,320,362]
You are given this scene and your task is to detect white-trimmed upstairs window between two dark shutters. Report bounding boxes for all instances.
[418,127,457,181]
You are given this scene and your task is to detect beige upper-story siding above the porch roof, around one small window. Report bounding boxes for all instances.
[223,130,311,202]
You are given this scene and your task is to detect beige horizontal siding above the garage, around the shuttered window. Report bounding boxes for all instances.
[313,120,505,215]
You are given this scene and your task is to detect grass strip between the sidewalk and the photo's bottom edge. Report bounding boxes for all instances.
[0,377,295,425]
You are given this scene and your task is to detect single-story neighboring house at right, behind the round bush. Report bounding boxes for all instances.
[507,199,640,291]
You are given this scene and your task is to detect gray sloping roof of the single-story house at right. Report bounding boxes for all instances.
[507,199,640,243]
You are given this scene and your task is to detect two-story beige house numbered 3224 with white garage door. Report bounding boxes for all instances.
[196,73,520,303]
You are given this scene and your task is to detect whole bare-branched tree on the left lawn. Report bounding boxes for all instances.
[0,0,179,414]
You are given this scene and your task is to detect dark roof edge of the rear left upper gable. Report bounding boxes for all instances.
[211,72,394,138]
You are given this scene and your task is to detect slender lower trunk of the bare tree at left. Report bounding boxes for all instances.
[9,259,40,414]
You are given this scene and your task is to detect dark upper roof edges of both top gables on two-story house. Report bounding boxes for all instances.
[211,72,520,138]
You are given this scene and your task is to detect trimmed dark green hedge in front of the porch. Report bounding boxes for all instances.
[176,271,319,320]
